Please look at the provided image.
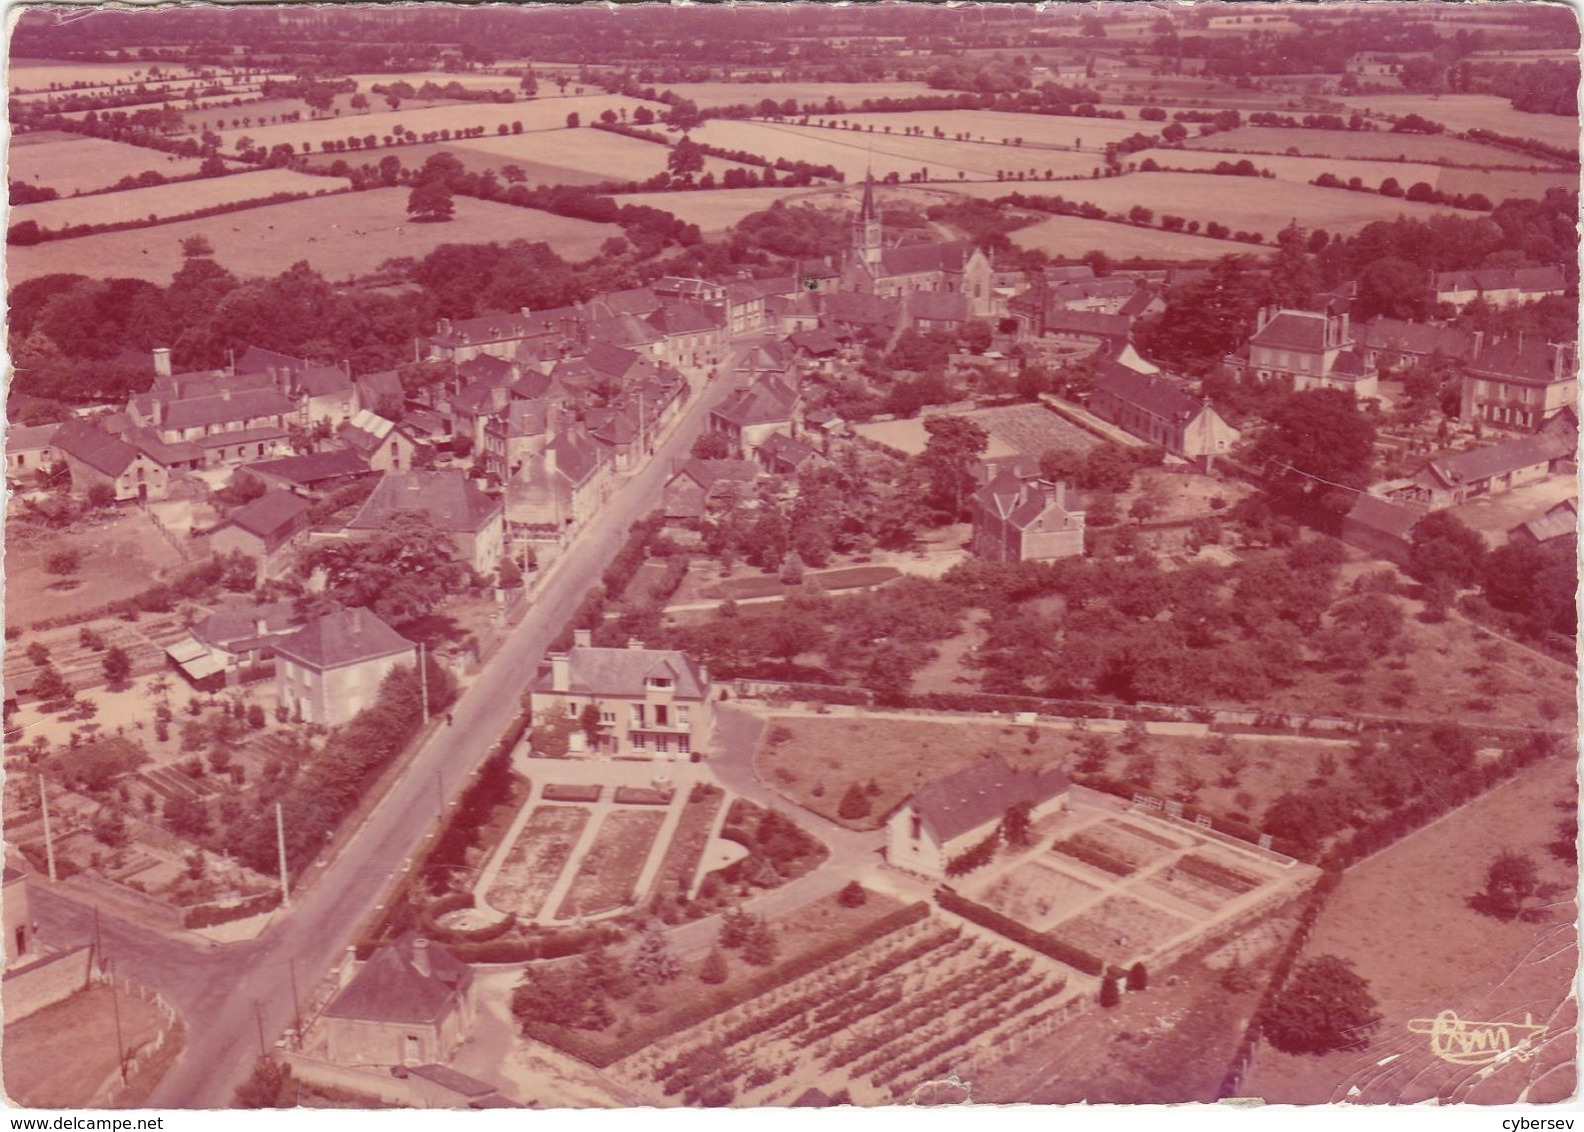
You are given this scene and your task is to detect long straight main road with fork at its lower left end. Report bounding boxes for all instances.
[33,359,747,1108]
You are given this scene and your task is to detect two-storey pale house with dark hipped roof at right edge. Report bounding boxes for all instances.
[1457,336,1579,429]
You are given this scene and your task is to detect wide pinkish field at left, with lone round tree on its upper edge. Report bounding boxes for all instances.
[6,188,621,285]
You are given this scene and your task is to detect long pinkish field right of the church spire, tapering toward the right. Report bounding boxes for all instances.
[1012,173,1449,235]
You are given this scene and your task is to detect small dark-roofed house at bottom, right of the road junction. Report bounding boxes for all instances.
[322,933,474,1066]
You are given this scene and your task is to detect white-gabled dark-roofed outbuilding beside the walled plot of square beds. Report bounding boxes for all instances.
[885,755,1069,880]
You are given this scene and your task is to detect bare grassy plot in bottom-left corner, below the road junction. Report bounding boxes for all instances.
[3,986,165,1108]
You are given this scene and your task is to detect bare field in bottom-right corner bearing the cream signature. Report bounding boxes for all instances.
[1242,758,1578,1104]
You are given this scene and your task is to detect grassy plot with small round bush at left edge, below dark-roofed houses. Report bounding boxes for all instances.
[6,511,181,625]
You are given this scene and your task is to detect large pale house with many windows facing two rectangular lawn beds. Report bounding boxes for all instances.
[529,629,714,758]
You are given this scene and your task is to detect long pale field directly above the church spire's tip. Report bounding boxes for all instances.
[694,114,1089,182]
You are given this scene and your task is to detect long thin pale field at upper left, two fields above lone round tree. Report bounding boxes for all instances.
[202,93,648,152]
